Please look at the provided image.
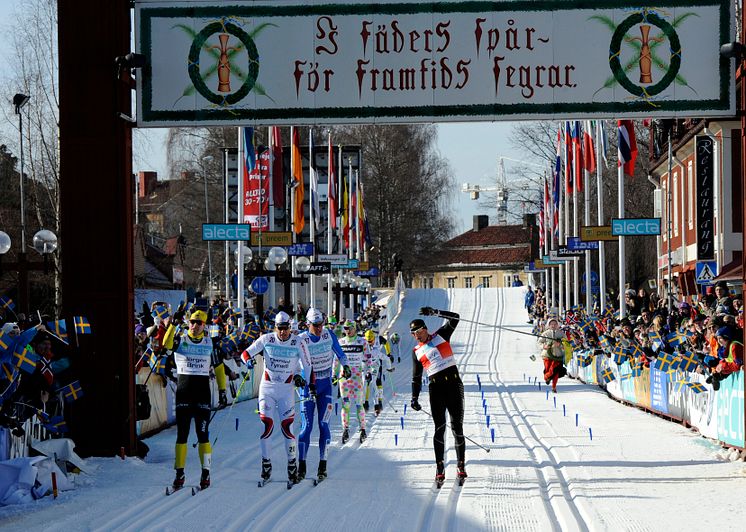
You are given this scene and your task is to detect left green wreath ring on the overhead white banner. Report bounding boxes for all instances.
[189,22,259,105]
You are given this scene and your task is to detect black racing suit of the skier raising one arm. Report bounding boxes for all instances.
[412,310,466,468]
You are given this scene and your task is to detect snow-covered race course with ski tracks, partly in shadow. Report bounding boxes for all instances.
[0,288,746,532]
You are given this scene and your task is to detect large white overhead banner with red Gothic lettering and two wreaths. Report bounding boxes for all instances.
[135,0,735,127]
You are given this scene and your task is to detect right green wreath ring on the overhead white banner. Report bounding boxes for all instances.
[609,13,681,98]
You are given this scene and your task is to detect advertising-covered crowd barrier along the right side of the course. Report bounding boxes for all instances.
[567,351,746,449]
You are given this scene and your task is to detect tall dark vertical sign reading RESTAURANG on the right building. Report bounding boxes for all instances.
[696,135,715,260]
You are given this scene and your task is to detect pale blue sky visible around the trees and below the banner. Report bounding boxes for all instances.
[0,0,521,233]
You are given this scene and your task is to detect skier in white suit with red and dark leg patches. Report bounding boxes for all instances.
[241,312,316,487]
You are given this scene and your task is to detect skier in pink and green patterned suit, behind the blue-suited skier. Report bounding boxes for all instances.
[334,320,370,443]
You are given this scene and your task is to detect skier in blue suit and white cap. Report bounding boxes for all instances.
[298,308,352,480]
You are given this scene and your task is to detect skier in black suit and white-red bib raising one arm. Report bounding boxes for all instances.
[409,307,466,485]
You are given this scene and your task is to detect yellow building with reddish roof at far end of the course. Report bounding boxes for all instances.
[412,214,539,288]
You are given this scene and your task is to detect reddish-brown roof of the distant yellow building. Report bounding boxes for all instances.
[432,225,532,269]
